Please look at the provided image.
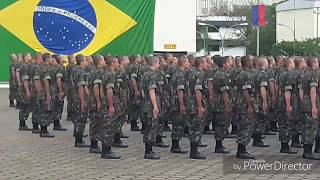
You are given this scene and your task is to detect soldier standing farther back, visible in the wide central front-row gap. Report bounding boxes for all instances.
[127,55,142,131]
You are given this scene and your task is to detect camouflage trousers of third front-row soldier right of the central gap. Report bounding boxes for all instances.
[188,114,205,143]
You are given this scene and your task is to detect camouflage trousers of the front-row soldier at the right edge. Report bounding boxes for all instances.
[302,112,318,144]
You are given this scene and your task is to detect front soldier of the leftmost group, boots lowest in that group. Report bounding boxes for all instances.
[34,53,54,138]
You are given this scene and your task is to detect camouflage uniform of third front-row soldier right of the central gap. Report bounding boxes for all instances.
[186,68,207,144]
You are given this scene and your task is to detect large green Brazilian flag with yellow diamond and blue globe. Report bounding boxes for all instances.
[0,0,155,81]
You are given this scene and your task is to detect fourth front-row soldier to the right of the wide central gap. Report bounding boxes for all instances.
[212,57,232,154]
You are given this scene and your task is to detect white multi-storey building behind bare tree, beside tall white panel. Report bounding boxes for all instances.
[197,16,248,56]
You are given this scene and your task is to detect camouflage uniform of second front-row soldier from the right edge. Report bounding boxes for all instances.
[278,70,299,143]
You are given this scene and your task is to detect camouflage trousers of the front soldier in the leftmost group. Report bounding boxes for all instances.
[36,99,53,126]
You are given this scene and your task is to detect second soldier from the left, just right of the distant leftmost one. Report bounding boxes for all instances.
[16,53,32,131]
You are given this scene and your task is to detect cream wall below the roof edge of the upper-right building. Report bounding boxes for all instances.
[277,8,320,42]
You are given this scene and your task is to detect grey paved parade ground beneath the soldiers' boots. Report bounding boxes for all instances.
[0,89,320,180]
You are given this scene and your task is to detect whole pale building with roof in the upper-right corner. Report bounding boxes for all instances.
[276,0,320,42]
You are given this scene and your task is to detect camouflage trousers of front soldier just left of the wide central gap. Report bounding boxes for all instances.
[100,113,118,146]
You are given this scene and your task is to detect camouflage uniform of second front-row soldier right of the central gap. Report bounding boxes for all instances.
[170,69,188,141]
